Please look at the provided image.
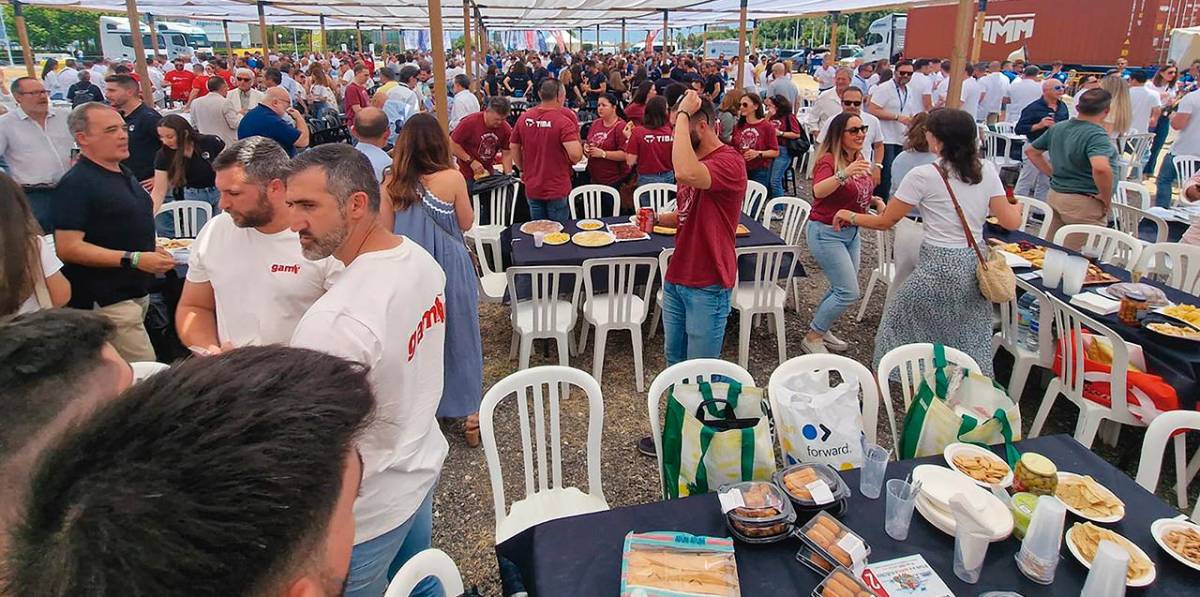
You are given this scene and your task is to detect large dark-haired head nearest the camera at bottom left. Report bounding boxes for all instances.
[0,346,374,596]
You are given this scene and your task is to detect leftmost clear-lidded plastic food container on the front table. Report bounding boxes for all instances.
[718,481,796,543]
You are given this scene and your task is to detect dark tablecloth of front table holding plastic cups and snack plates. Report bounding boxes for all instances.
[496,435,1200,597]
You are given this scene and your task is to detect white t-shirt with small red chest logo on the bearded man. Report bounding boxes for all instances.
[187,213,342,346]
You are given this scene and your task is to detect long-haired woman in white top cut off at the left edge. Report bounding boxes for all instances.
[0,174,71,319]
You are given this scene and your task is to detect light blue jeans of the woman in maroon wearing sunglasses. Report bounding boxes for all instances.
[805,219,862,334]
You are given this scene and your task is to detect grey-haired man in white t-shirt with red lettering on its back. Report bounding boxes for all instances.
[287,144,452,597]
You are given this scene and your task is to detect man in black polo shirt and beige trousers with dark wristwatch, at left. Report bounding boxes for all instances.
[53,102,175,362]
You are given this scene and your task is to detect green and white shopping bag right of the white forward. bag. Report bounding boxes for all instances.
[900,344,1021,466]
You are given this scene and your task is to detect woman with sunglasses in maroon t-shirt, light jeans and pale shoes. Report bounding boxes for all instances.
[800,111,883,354]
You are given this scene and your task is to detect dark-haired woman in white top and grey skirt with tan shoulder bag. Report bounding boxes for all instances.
[834,108,1021,376]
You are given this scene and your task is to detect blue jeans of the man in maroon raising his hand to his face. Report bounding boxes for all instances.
[662,282,733,367]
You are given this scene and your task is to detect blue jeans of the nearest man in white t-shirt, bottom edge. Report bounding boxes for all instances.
[346,489,442,597]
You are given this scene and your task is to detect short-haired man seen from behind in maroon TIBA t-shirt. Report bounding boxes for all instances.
[509,79,583,222]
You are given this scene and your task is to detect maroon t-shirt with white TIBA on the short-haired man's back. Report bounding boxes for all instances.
[509,105,580,199]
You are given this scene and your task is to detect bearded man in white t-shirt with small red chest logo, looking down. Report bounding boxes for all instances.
[175,137,342,352]
